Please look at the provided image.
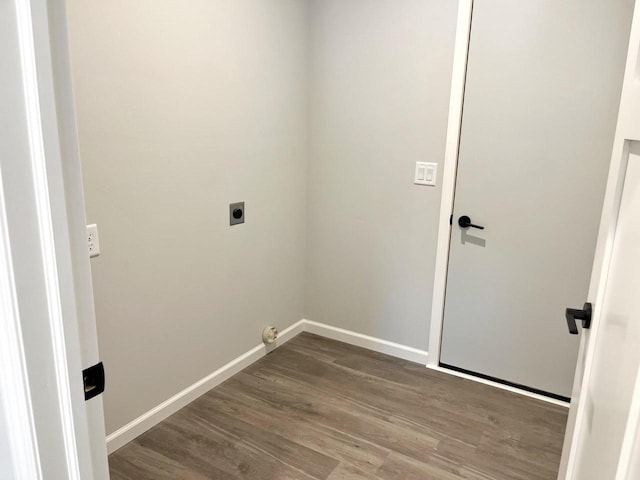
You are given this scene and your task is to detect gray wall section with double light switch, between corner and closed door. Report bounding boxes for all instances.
[305,0,457,350]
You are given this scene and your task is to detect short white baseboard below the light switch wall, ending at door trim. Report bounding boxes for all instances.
[303,320,427,365]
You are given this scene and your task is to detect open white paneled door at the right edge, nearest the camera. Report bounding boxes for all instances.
[558,0,640,480]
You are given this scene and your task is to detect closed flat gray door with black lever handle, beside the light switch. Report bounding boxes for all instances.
[440,0,633,398]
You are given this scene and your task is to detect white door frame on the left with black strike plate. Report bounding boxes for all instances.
[0,0,109,480]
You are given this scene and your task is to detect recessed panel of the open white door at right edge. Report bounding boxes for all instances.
[574,142,640,480]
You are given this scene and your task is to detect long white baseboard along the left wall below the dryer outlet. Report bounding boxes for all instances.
[107,320,305,453]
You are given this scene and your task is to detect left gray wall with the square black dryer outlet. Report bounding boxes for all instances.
[69,0,307,433]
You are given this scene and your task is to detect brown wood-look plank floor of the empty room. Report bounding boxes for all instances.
[109,333,567,480]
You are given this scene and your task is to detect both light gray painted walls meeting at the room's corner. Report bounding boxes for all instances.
[69,0,456,433]
